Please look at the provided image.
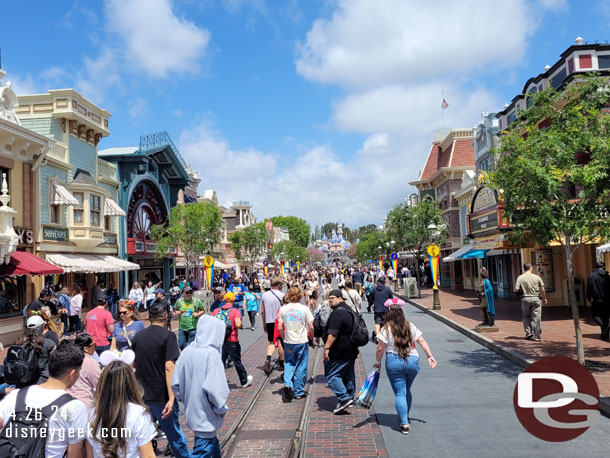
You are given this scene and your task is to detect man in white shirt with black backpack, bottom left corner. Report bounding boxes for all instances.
[0,341,87,458]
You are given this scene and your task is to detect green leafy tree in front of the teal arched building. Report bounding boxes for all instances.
[150,202,222,277]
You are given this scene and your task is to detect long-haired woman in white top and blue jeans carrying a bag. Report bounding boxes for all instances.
[373,299,436,434]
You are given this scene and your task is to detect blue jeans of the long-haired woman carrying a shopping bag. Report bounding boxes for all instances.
[385,353,419,425]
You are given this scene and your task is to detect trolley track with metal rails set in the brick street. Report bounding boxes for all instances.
[221,347,323,458]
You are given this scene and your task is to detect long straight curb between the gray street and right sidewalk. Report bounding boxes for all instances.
[396,294,610,418]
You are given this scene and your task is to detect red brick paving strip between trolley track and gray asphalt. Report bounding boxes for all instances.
[305,357,388,458]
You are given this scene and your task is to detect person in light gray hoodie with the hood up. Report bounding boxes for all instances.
[172,315,229,458]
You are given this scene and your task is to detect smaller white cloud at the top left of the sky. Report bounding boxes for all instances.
[105,0,210,78]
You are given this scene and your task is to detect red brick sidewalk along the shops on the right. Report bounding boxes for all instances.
[399,289,610,397]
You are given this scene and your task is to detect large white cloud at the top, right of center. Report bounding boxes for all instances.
[296,0,535,88]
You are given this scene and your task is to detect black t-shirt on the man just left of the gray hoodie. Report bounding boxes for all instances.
[131,325,180,404]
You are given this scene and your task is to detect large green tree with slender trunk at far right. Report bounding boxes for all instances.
[489,76,610,364]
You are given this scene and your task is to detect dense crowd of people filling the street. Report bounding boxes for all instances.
[0,266,436,457]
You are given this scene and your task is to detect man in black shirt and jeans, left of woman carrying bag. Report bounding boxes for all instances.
[323,289,358,415]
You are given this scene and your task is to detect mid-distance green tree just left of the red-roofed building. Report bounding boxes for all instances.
[385,200,447,293]
